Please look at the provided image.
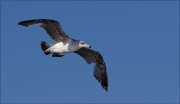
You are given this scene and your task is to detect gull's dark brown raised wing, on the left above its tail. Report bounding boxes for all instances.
[18,19,69,42]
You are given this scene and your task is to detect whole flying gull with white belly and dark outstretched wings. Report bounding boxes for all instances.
[18,19,108,91]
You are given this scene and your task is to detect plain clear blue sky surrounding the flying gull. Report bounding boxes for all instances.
[1,1,179,103]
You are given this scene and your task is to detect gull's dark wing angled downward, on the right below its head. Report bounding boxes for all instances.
[75,48,108,91]
